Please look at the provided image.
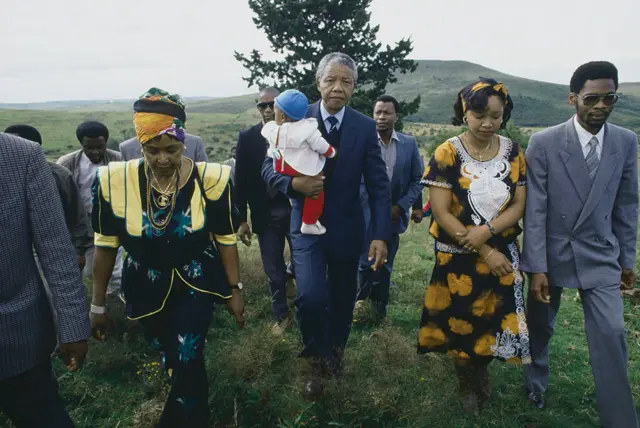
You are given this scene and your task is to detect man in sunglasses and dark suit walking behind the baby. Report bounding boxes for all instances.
[234,88,292,335]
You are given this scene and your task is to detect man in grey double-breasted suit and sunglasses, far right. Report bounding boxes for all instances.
[522,62,638,428]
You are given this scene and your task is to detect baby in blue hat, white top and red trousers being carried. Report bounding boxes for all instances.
[262,89,337,235]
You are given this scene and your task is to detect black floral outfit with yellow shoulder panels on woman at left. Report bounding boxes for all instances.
[92,160,236,427]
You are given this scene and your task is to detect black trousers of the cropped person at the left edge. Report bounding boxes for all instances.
[0,361,74,428]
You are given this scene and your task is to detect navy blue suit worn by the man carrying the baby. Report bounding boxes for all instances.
[262,102,391,362]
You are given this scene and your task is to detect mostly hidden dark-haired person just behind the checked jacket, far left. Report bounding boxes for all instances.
[4,125,92,270]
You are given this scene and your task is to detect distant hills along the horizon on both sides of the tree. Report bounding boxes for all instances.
[0,60,640,130]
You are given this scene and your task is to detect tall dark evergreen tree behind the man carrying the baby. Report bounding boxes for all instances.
[235,0,420,129]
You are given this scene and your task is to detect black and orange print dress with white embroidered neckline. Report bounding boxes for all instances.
[418,137,531,364]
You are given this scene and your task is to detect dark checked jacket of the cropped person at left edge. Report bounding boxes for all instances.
[0,133,91,380]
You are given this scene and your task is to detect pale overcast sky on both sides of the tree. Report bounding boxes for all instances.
[0,0,640,102]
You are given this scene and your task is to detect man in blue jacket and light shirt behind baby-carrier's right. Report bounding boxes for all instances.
[354,95,424,319]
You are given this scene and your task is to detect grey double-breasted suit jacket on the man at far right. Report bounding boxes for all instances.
[522,119,638,289]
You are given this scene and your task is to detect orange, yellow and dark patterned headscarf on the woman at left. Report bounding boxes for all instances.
[133,88,187,145]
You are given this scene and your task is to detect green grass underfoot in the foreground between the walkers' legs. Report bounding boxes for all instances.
[0,223,640,428]
